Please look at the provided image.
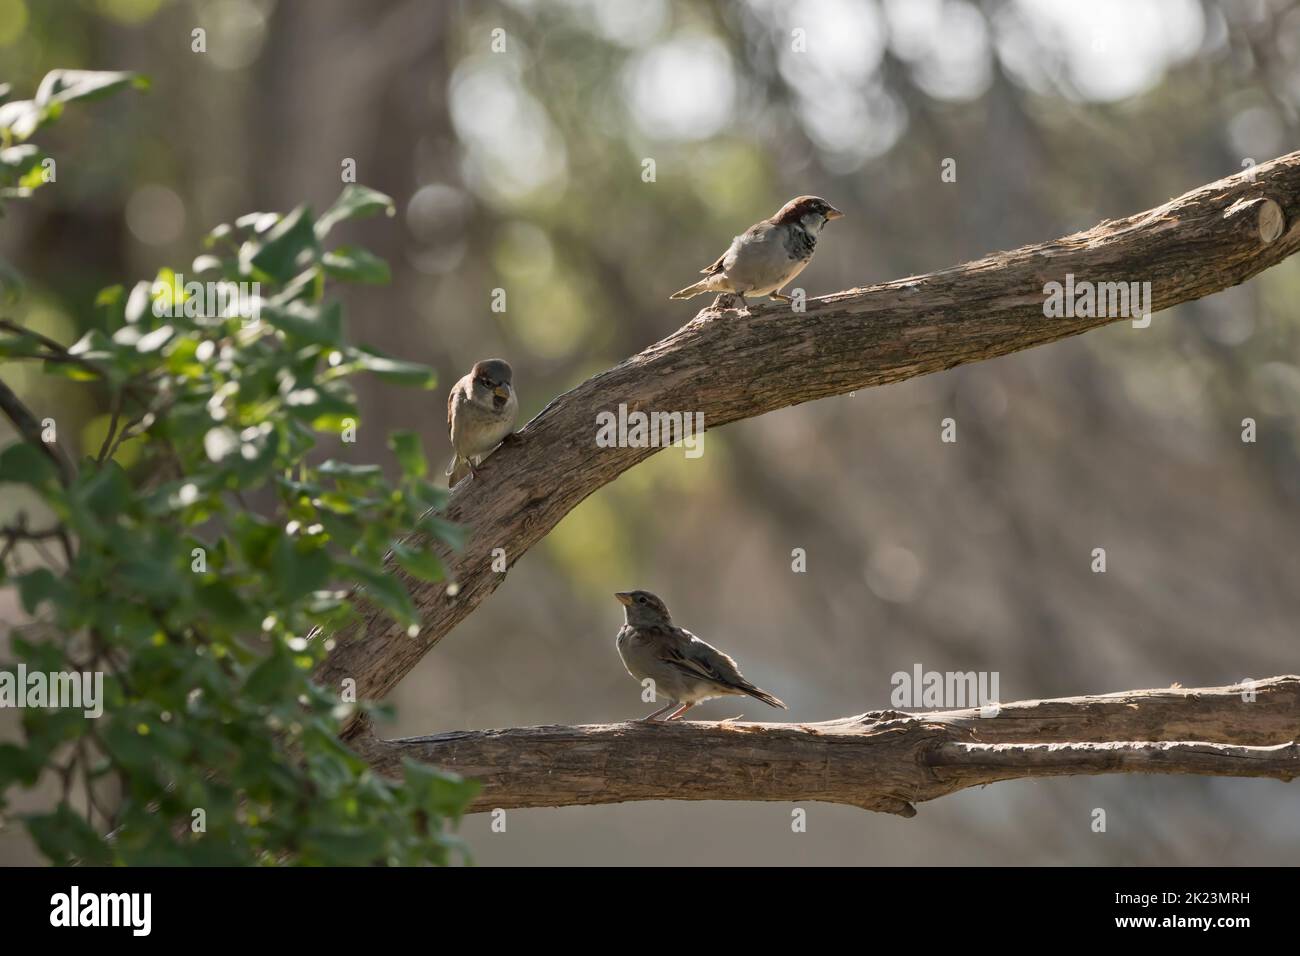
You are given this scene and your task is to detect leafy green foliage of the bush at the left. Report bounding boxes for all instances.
[0,72,475,865]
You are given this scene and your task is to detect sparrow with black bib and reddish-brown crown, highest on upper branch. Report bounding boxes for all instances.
[668,196,844,308]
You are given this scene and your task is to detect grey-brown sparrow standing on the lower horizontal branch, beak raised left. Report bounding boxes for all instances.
[615,591,785,721]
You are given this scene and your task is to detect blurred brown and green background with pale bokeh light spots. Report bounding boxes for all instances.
[0,0,1300,865]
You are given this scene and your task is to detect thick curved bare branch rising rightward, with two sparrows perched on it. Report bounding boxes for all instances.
[316,152,1300,734]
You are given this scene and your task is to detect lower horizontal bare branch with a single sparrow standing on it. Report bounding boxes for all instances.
[352,676,1300,817]
